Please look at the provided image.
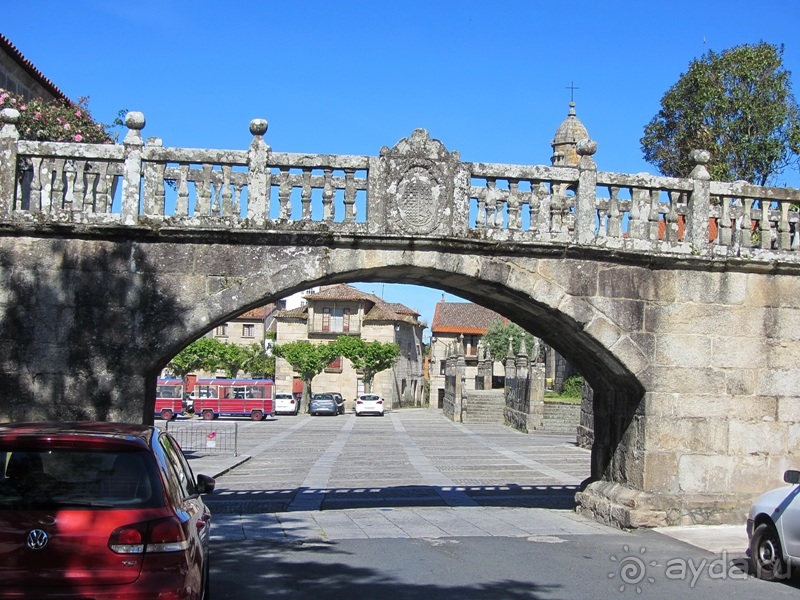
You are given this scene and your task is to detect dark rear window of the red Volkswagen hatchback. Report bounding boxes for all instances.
[0,447,164,510]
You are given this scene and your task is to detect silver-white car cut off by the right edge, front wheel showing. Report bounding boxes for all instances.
[747,470,800,581]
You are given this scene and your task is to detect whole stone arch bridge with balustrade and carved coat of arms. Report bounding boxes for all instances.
[0,109,800,527]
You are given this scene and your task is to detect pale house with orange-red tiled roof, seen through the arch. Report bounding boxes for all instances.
[429,297,507,408]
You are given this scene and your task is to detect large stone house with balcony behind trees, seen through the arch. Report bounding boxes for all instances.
[275,284,425,409]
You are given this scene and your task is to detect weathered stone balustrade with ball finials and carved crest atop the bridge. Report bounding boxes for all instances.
[0,109,800,262]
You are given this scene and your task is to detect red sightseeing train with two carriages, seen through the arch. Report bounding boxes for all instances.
[155,375,275,421]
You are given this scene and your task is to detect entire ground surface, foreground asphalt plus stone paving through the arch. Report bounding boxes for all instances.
[172,410,798,600]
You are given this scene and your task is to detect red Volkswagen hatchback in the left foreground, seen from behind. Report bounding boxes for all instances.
[0,423,214,600]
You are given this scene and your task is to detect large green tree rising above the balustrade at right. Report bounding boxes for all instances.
[641,42,800,185]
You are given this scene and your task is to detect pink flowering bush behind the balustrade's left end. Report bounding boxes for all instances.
[0,88,116,144]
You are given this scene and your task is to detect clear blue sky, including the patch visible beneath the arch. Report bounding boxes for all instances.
[0,0,800,336]
